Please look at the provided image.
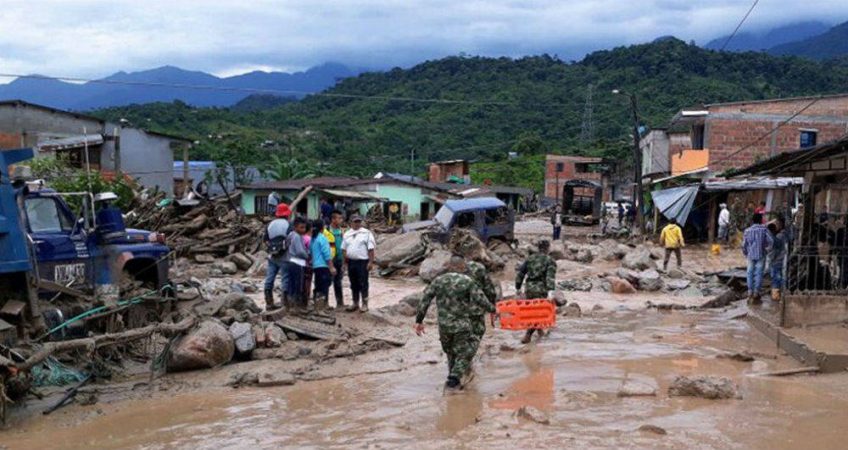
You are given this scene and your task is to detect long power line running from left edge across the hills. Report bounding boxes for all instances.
[0,73,524,107]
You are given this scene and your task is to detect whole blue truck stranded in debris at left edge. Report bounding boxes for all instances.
[0,149,170,343]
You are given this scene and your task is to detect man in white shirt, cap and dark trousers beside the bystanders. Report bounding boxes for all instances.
[342,214,377,312]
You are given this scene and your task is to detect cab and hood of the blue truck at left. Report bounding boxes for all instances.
[20,185,170,297]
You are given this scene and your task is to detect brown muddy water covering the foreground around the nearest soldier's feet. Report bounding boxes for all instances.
[0,311,848,449]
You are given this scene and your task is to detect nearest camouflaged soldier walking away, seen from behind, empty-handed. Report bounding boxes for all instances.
[415,256,495,389]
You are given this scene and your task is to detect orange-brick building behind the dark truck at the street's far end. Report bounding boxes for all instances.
[545,155,612,201]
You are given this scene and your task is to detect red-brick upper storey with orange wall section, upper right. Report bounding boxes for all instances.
[668,94,848,175]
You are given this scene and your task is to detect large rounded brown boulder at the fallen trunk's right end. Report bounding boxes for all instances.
[167,320,235,372]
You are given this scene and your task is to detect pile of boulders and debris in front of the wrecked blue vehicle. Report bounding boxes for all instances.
[376,228,514,282]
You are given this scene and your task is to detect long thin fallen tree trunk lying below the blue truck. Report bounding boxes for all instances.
[15,317,194,371]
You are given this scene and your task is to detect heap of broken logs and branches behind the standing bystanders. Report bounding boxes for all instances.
[126,193,264,257]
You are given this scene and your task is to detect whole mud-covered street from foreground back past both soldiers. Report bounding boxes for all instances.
[0,221,848,449]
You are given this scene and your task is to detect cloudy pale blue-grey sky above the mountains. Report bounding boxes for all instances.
[0,0,848,78]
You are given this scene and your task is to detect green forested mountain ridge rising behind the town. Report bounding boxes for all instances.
[96,39,848,188]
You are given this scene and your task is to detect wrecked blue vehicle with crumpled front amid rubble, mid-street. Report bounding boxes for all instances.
[403,197,515,243]
